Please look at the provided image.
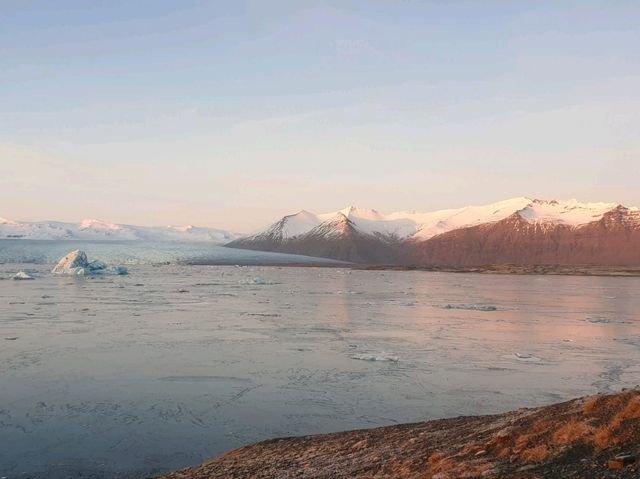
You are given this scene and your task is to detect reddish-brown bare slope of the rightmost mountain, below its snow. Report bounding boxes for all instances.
[410,206,640,266]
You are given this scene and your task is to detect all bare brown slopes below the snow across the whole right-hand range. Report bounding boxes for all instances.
[227,206,640,267]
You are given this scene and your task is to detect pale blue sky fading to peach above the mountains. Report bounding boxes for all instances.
[0,0,640,232]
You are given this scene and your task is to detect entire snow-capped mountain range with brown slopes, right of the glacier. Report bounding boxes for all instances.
[229,197,640,266]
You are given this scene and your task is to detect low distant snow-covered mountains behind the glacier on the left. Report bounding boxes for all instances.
[0,218,239,243]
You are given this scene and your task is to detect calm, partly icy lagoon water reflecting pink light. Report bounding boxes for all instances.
[0,264,640,478]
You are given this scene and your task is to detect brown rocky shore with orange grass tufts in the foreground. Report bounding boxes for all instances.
[162,388,640,479]
